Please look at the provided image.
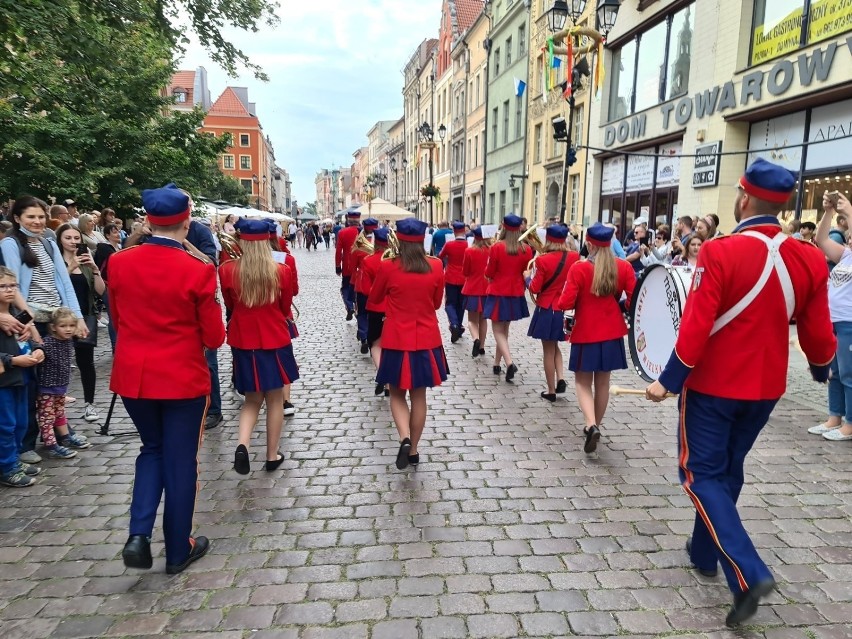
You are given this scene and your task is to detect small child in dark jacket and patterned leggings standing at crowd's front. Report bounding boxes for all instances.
[36,307,92,459]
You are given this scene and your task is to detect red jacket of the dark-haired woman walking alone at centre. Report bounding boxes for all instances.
[367,257,444,351]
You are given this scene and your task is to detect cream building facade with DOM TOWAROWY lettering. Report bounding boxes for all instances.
[589,0,852,232]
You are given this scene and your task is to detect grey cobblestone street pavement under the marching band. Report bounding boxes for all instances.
[0,251,852,639]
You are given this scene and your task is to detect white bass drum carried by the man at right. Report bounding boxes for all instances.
[627,264,693,382]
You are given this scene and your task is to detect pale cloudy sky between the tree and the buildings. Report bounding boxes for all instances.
[180,0,441,204]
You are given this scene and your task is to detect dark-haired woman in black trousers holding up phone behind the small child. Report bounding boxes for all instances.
[56,224,106,422]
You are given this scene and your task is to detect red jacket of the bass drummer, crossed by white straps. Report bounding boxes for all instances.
[660,216,837,400]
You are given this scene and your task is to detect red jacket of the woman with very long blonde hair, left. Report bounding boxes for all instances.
[219,261,293,350]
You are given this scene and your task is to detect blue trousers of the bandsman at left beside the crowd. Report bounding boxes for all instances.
[121,396,208,565]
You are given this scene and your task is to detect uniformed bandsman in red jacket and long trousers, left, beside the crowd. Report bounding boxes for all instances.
[108,184,225,574]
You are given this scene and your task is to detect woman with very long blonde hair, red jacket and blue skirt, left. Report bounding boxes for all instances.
[219,219,299,475]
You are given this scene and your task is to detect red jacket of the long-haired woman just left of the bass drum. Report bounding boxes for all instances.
[556,259,636,344]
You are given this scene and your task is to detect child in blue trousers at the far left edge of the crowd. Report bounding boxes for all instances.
[0,266,44,488]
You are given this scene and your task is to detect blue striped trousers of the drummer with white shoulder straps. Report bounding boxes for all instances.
[678,389,777,593]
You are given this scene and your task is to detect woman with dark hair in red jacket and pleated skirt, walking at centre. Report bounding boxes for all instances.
[368,218,449,470]
